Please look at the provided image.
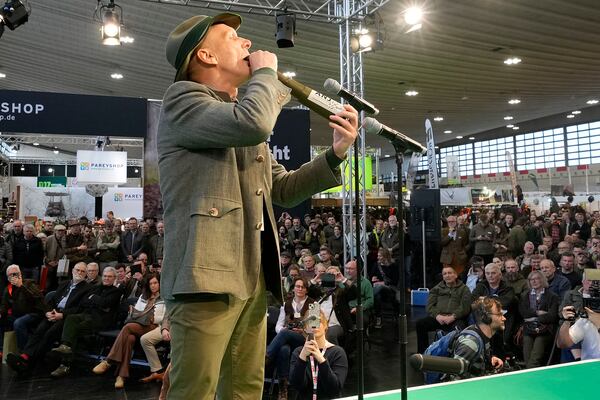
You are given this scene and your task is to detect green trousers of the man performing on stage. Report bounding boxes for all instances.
[167,276,267,400]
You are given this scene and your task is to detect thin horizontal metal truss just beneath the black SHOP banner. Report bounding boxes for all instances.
[0,133,144,147]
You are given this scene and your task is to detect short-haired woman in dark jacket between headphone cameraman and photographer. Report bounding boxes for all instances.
[519,271,559,368]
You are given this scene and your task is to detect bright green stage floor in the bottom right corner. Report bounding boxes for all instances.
[347,360,600,400]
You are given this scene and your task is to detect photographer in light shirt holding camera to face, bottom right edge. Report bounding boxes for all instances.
[557,306,600,360]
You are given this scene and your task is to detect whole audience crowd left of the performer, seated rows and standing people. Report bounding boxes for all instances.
[0,213,170,388]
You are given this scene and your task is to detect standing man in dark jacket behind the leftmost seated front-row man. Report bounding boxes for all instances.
[13,224,44,281]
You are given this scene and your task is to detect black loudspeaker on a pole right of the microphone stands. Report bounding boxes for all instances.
[408,189,442,241]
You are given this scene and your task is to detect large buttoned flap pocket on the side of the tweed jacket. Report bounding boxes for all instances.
[183,197,244,271]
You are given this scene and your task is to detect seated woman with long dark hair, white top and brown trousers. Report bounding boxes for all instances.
[93,274,165,389]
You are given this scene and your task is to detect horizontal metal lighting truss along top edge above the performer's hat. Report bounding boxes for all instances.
[136,0,390,23]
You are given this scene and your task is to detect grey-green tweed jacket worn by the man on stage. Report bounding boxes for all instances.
[157,68,339,300]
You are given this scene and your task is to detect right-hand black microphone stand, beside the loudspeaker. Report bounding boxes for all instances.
[390,145,408,400]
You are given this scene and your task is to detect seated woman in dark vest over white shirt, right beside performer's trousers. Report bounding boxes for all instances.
[265,277,314,400]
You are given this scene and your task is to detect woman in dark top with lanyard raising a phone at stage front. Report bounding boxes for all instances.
[290,312,348,400]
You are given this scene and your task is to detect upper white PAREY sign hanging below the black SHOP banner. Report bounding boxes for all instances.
[77,150,127,184]
